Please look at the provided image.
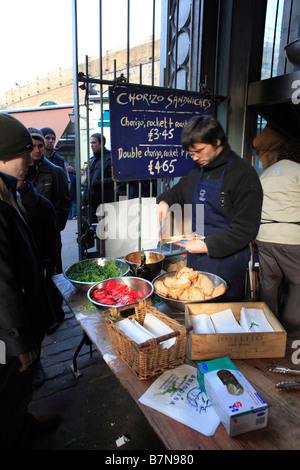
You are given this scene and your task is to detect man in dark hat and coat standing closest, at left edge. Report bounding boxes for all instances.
[0,113,58,450]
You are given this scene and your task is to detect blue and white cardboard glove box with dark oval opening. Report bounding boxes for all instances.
[197,357,268,436]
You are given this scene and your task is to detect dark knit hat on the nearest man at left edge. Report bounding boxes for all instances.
[0,112,33,160]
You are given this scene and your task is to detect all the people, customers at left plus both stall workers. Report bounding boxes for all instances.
[0,113,300,449]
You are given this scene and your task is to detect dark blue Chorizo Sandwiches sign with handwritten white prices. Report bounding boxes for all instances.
[109,87,214,181]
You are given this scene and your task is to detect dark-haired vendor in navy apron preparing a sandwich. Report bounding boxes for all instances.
[158,116,262,301]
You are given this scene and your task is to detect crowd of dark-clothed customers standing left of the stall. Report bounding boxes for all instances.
[0,112,119,450]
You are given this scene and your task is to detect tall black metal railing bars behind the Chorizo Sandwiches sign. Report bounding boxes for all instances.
[72,0,179,259]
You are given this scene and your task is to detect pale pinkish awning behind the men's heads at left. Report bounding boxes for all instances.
[8,106,74,142]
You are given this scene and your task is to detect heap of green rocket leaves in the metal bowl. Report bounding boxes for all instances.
[66,259,122,282]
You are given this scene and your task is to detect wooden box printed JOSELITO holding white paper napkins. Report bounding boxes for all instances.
[185,302,287,361]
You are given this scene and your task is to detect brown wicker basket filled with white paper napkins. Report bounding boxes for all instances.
[105,302,191,380]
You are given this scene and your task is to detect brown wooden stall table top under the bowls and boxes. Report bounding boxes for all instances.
[53,274,300,451]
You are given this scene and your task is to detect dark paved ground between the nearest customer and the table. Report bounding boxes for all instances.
[30,306,164,451]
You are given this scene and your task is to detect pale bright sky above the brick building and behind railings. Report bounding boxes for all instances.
[0,0,160,95]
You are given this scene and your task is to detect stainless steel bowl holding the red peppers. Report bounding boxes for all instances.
[87,277,154,309]
